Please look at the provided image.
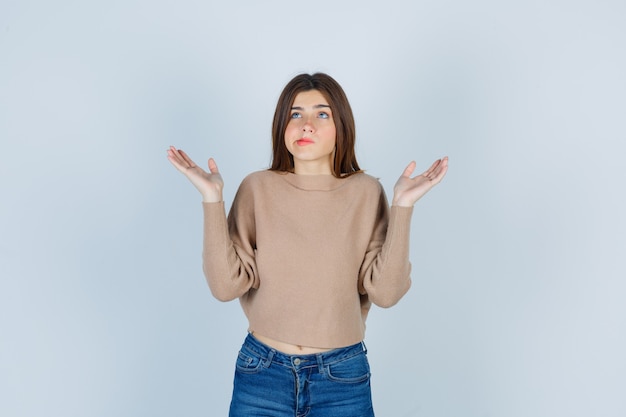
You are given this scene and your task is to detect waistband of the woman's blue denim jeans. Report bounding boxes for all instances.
[242,333,367,368]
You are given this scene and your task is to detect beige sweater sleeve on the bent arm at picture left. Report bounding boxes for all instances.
[202,177,259,301]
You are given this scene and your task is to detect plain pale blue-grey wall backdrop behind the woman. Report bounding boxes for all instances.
[0,0,626,417]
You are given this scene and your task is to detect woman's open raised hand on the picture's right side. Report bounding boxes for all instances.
[392,156,448,207]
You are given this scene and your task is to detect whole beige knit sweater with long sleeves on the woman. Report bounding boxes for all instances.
[203,171,413,348]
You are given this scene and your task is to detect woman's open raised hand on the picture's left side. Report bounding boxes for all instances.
[167,146,224,203]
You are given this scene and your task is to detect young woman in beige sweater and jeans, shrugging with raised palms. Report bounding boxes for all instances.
[168,73,448,417]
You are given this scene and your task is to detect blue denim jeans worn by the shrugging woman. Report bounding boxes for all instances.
[229,334,374,417]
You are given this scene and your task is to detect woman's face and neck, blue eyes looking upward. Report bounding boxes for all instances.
[285,90,337,175]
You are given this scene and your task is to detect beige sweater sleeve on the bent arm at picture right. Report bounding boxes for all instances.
[359,187,413,307]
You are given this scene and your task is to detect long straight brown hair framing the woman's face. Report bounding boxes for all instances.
[270,72,361,178]
